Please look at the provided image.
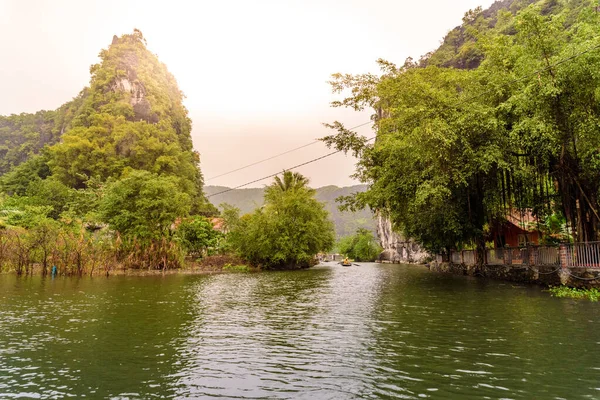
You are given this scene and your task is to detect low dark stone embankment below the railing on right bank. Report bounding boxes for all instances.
[429,262,600,289]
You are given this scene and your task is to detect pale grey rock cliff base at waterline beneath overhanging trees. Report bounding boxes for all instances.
[377,213,430,263]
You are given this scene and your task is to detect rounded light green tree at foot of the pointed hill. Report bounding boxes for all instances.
[100,171,190,240]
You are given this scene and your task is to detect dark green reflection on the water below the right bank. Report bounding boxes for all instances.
[373,266,600,399]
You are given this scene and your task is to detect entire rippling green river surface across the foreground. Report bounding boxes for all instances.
[0,264,600,399]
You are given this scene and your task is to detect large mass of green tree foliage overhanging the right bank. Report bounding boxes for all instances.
[324,0,600,251]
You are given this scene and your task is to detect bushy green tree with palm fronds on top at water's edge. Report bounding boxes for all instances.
[228,172,334,269]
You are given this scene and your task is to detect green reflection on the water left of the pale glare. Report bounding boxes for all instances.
[0,276,202,398]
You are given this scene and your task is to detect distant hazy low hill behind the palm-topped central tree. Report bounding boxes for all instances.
[204,185,376,237]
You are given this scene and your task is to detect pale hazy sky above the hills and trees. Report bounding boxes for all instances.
[0,0,493,187]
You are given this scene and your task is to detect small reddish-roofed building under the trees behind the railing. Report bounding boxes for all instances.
[490,211,541,248]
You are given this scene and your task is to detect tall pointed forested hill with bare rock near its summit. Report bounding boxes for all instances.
[0,30,212,216]
